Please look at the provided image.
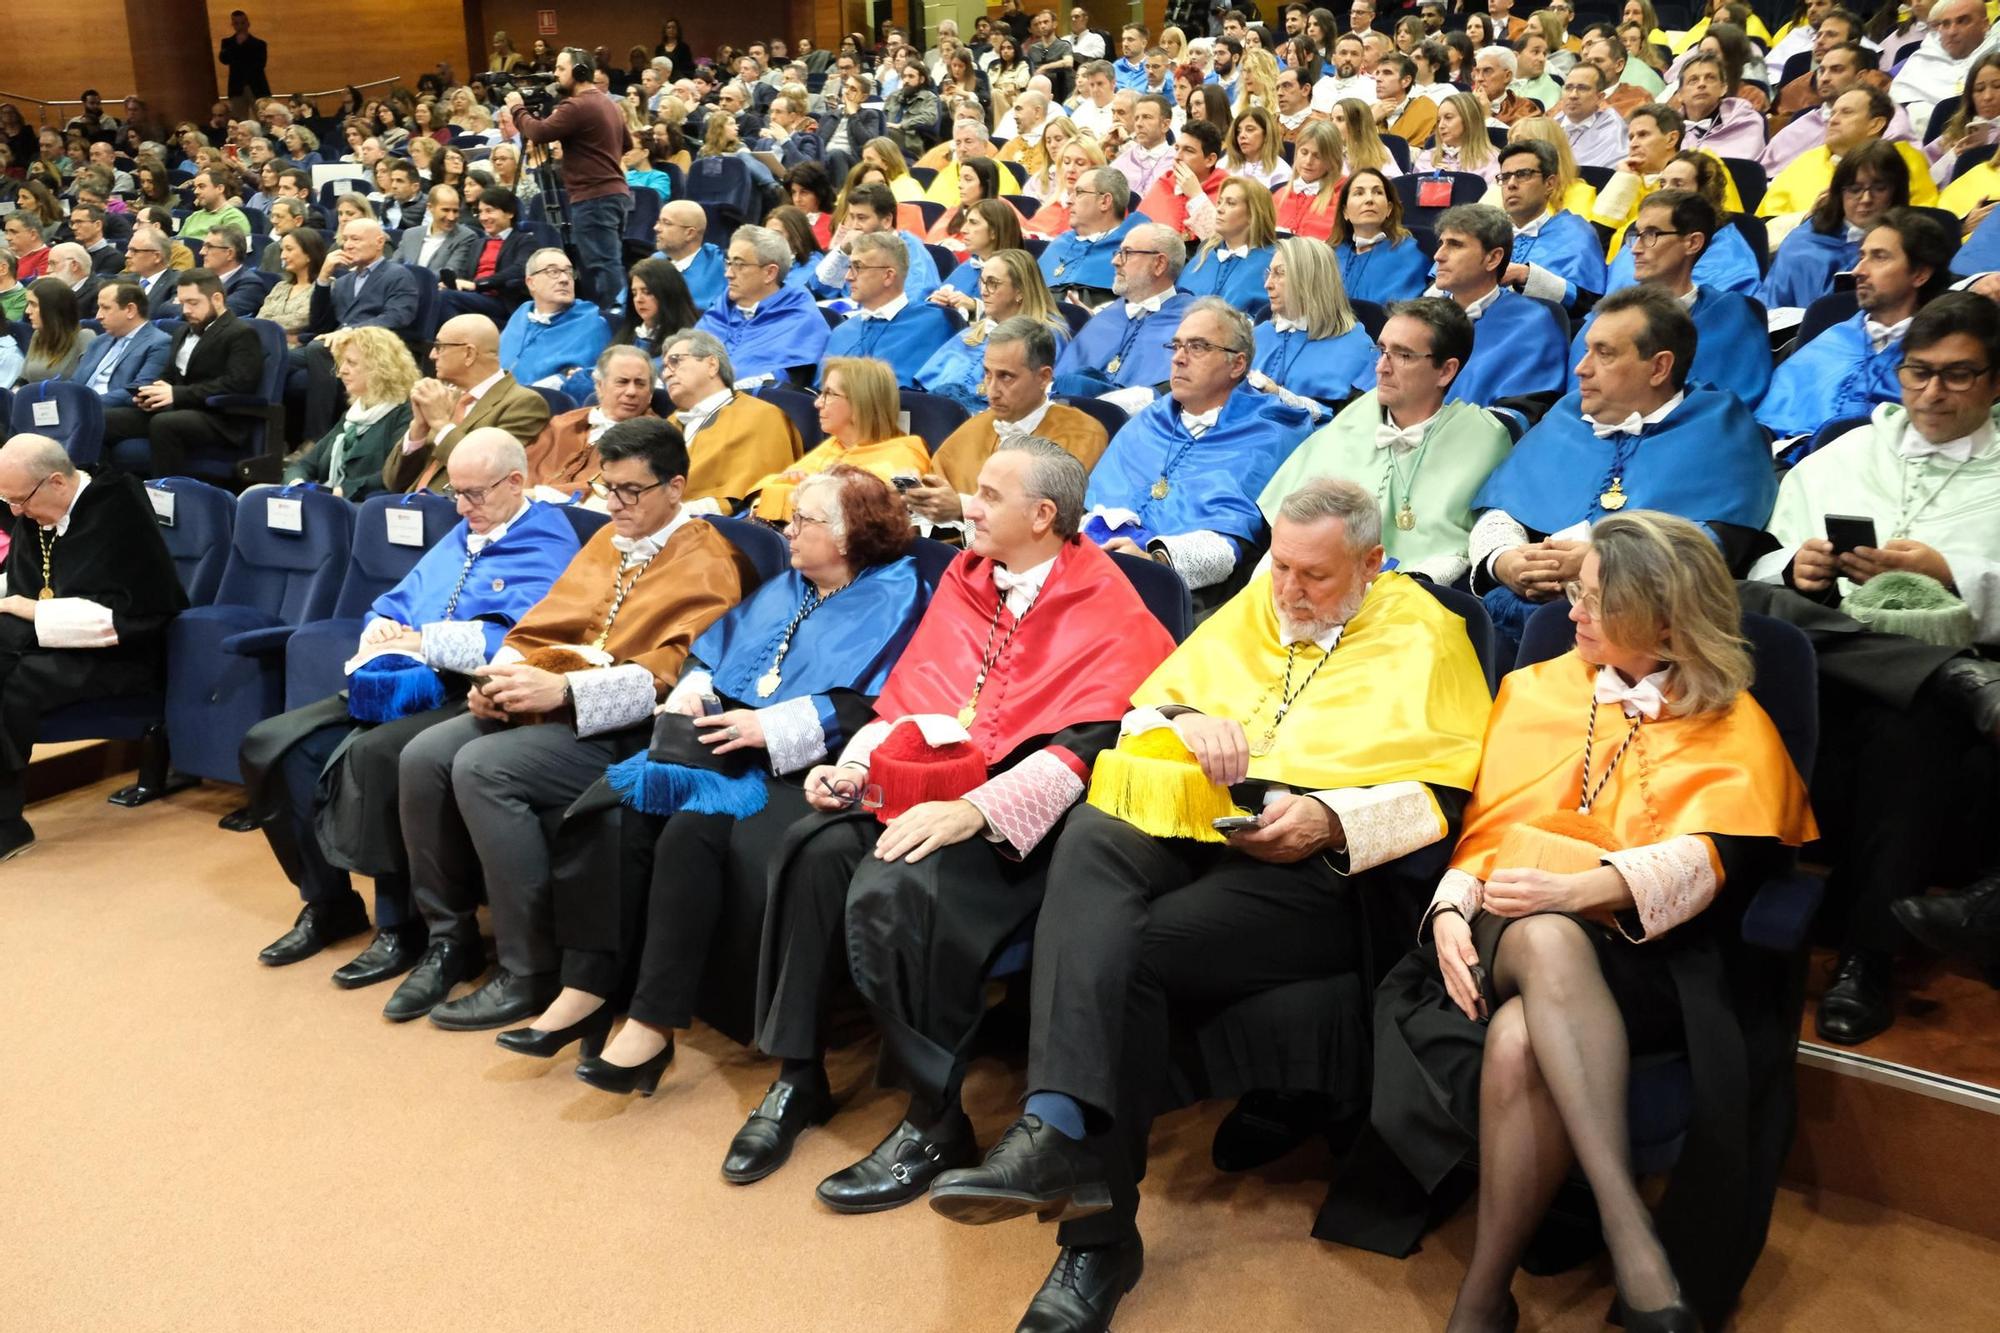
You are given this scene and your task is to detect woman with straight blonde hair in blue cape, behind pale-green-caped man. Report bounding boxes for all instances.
[1250,236,1376,404]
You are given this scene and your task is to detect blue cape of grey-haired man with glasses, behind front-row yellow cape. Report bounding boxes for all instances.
[1084,388,1310,546]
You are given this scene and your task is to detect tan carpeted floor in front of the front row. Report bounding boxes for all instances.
[0,768,2000,1333]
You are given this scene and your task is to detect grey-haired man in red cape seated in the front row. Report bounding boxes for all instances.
[722,436,1174,1213]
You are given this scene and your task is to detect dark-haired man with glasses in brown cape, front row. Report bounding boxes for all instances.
[382,418,756,1031]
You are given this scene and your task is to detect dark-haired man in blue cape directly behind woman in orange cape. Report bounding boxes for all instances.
[1470,286,1778,646]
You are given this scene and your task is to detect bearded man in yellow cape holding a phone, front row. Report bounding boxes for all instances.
[928,480,1490,1329]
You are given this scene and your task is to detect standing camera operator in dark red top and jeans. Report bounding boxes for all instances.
[500,46,632,310]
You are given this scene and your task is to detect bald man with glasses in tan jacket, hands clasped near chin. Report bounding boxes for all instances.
[382,314,548,490]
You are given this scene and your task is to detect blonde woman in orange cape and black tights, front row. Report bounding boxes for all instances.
[1354,506,1818,1333]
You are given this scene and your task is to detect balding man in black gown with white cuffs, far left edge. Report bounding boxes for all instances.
[0,434,188,861]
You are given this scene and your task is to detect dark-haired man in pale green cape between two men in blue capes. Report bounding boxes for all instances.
[1258,296,1514,586]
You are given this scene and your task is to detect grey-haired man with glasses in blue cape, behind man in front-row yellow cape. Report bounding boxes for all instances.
[1084,296,1310,604]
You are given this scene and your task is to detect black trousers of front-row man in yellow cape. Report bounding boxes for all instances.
[1028,807,1362,1245]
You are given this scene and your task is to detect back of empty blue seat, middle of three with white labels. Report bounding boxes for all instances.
[216,486,354,624]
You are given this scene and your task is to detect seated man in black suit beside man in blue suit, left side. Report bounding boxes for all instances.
[104,268,264,476]
